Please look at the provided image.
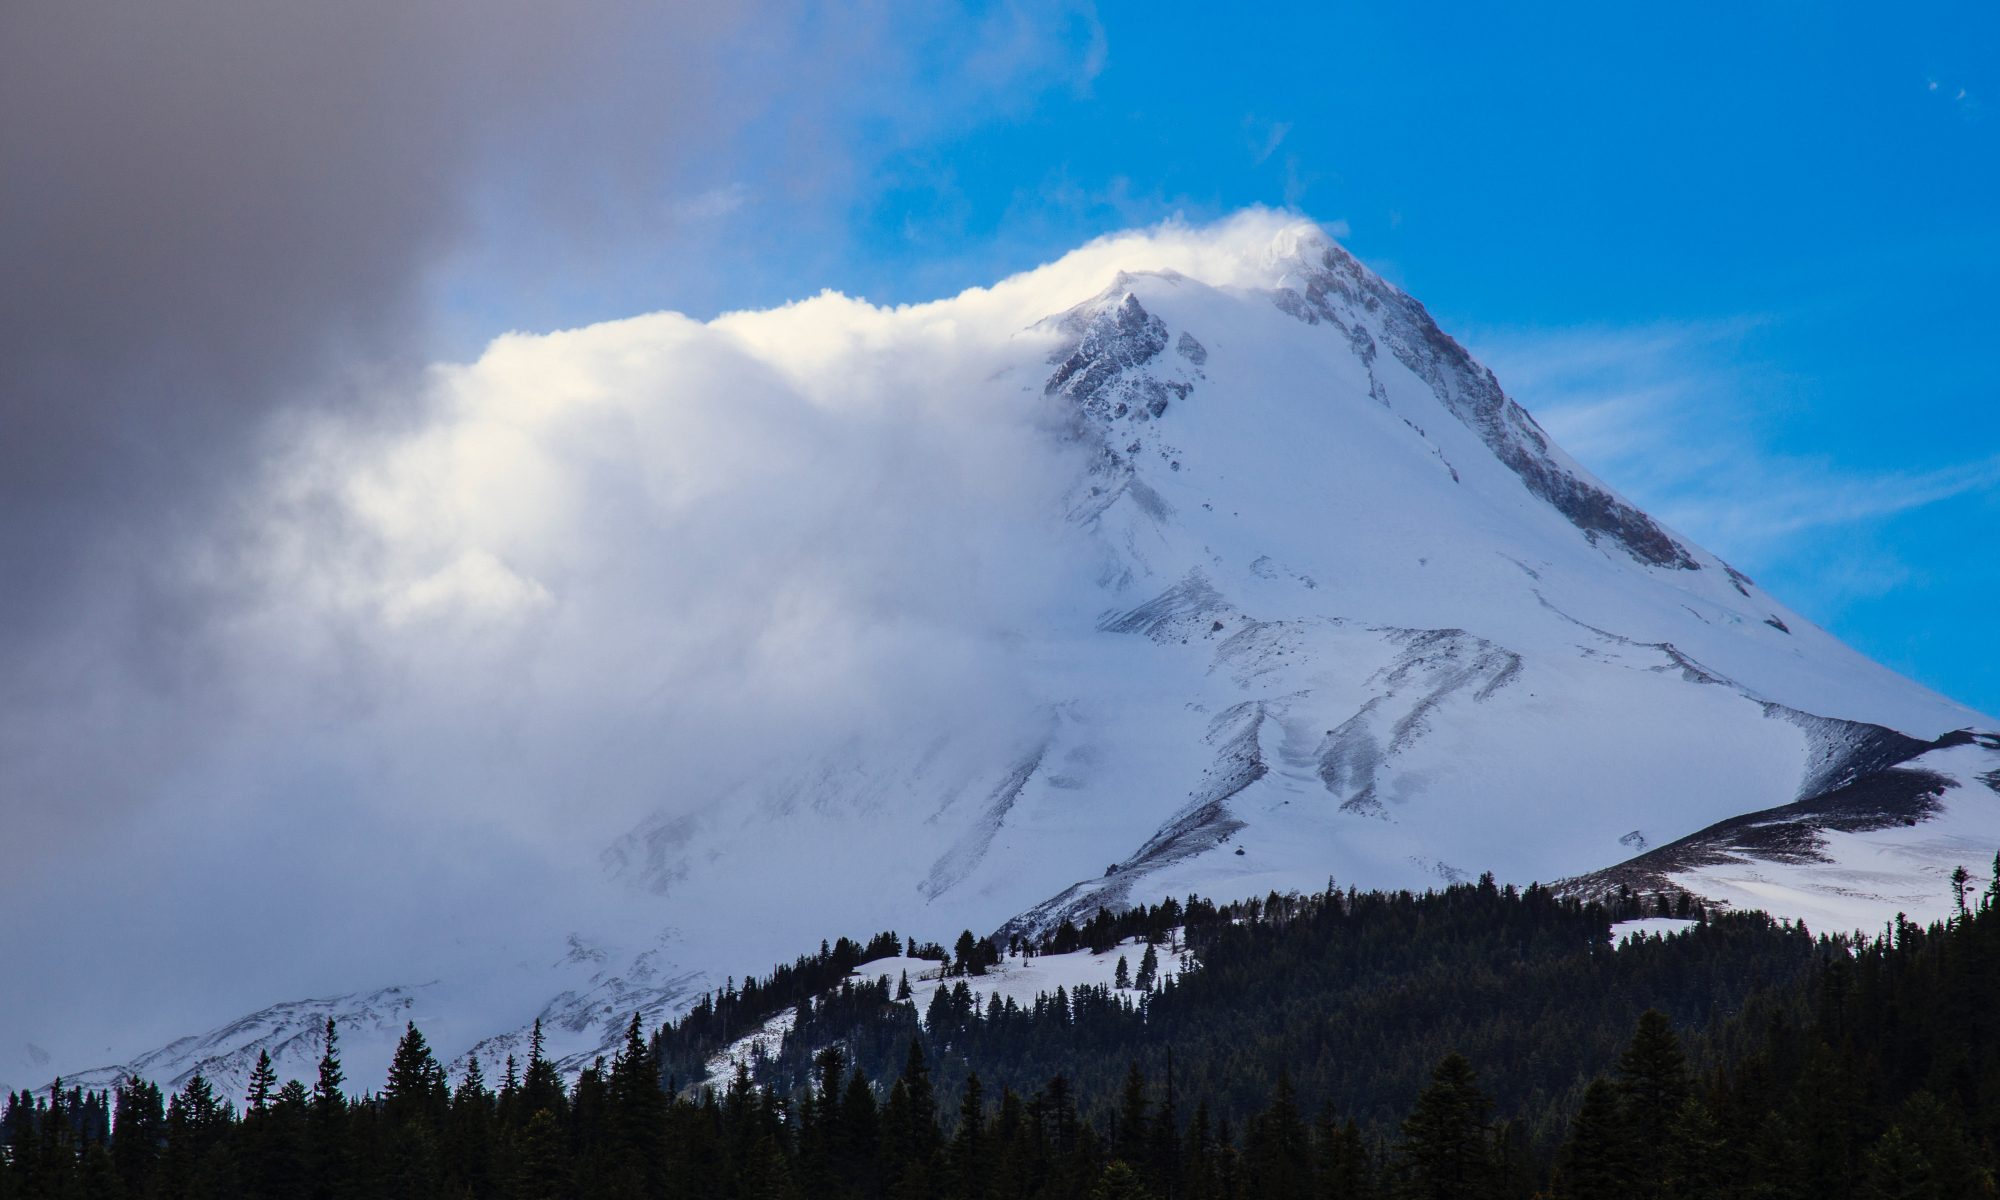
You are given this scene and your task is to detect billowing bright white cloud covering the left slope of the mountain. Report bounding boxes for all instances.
[0,214,1284,1088]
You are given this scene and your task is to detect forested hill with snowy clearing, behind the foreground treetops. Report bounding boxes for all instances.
[728,878,1822,1144]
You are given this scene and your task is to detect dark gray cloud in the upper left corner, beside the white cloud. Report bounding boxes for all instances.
[0,0,758,866]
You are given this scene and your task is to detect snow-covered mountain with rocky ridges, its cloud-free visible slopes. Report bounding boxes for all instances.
[35,214,2000,1090]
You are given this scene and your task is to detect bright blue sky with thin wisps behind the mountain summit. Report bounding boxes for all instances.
[448,2,2000,714]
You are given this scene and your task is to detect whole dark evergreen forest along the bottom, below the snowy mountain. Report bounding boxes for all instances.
[0,874,2000,1200]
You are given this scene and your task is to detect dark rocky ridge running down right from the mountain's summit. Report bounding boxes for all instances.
[1274,242,1700,570]
